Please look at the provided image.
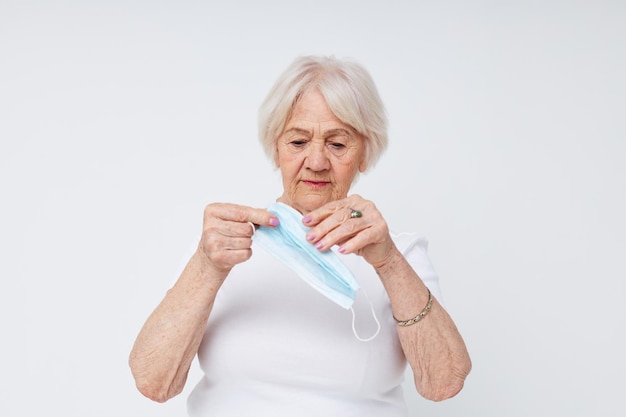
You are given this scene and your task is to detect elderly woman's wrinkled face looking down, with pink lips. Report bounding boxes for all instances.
[276,90,366,214]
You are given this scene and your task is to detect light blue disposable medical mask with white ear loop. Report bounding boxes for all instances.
[253,203,380,341]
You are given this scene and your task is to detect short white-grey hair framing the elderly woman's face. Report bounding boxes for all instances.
[259,55,388,169]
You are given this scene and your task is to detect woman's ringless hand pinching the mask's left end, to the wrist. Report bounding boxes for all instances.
[197,203,278,277]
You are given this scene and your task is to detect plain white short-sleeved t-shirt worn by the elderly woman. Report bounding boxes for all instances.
[187,234,440,417]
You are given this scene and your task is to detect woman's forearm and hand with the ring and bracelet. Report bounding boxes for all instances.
[303,195,471,401]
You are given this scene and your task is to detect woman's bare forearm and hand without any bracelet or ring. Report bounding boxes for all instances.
[129,204,278,402]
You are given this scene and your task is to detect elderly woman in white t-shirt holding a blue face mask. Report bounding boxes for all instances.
[130,57,471,417]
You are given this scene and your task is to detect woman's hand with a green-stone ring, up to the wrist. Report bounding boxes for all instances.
[302,194,396,268]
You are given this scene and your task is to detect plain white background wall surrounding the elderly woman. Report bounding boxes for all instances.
[0,0,626,417]
